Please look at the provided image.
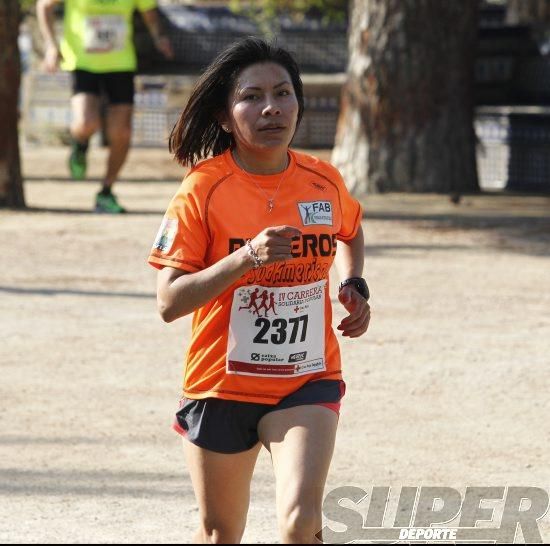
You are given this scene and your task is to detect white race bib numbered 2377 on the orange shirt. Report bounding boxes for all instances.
[226,280,326,378]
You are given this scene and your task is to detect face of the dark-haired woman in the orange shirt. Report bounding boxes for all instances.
[222,62,298,152]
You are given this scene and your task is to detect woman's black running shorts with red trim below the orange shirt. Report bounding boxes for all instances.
[173,379,346,453]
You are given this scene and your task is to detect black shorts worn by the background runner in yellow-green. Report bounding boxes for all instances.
[72,70,135,104]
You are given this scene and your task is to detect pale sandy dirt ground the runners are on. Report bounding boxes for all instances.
[0,144,550,543]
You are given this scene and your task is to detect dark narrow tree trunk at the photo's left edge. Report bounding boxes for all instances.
[0,0,25,208]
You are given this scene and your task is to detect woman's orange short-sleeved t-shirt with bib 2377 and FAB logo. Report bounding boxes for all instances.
[149,150,361,404]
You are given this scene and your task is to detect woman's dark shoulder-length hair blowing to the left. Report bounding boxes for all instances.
[169,37,304,166]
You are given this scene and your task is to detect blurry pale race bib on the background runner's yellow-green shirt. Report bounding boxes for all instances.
[84,15,128,53]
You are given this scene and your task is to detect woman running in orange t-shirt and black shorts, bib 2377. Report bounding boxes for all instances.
[149,38,370,543]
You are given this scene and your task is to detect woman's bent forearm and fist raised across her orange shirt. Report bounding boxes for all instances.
[157,226,300,322]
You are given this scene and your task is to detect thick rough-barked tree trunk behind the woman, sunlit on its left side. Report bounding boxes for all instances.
[332,0,479,194]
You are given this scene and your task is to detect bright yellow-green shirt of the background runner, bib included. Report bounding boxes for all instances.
[61,0,157,73]
